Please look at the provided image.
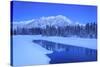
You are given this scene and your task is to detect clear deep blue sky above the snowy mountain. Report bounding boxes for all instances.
[11,1,97,23]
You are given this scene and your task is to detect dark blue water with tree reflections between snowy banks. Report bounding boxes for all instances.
[33,40,97,64]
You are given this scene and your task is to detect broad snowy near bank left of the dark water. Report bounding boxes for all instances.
[12,36,51,66]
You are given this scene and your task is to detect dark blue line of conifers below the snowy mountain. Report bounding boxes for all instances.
[11,22,97,38]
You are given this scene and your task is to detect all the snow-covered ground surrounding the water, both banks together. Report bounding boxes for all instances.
[12,35,97,66]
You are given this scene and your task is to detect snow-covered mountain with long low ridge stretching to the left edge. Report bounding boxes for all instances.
[13,15,83,29]
